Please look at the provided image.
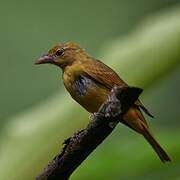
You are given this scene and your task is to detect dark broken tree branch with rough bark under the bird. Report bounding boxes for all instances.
[36,87,142,180]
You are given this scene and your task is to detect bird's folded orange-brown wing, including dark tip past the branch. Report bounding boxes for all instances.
[83,58,153,117]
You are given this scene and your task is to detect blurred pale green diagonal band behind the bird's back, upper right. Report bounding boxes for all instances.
[100,7,180,87]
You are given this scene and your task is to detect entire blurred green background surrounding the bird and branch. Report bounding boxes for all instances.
[0,0,180,180]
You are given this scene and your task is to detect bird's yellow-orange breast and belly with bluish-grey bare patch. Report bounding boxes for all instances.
[64,71,109,112]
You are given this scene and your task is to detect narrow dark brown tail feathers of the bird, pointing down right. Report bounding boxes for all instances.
[143,128,171,163]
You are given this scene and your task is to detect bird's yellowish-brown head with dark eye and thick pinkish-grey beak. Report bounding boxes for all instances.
[35,42,86,69]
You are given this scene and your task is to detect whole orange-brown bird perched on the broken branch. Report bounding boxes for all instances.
[35,42,171,163]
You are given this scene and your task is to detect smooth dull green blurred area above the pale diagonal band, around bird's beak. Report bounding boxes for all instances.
[0,0,179,122]
